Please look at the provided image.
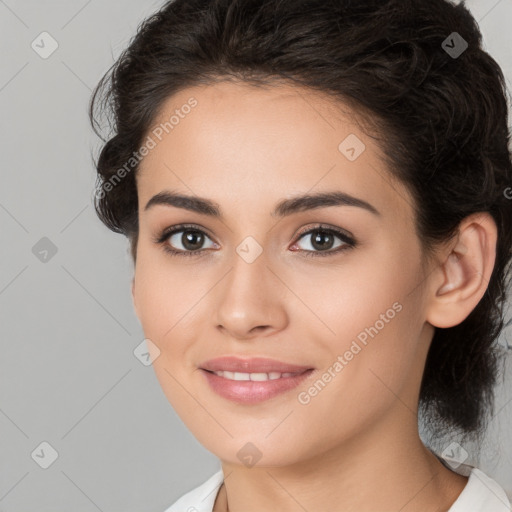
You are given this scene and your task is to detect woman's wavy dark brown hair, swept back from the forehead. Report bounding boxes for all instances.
[89,0,512,446]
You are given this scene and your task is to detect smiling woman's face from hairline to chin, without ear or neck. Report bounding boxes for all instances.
[133,82,433,465]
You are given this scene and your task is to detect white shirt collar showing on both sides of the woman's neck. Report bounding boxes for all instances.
[164,464,512,512]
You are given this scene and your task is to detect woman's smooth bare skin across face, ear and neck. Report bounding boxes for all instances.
[132,82,497,512]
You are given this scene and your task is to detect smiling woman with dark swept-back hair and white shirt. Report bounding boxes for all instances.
[90,0,512,512]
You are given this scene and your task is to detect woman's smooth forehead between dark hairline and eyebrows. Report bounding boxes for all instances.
[138,82,412,221]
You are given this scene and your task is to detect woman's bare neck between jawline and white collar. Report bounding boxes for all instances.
[214,401,467,512]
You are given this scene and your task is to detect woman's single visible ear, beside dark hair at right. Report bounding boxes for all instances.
[426,212,497,328]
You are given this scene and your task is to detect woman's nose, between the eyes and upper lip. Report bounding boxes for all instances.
[214,247,288,340]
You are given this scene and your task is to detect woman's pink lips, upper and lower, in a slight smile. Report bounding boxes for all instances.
[201,357,314,404]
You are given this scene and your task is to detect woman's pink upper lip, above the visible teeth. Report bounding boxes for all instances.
[200,356,312,373]
